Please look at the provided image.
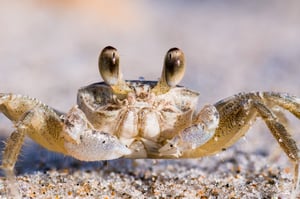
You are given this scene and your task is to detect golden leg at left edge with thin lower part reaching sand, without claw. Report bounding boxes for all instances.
[0,93,64,198]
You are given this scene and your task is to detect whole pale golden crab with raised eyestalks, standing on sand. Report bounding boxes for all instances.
[0,46,300,197]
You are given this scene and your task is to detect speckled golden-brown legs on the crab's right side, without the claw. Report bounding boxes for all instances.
[186,92,300,195]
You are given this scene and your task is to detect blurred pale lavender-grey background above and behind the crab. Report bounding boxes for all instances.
[0,0,300,197]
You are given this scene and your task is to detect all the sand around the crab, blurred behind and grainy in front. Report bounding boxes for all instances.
[0,0,300,198]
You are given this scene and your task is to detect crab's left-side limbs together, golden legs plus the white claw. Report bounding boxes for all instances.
[0,94,131,198]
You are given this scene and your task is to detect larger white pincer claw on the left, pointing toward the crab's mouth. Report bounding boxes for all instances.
[63,106,131,161]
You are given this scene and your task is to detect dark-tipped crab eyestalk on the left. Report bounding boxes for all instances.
[98,46,130,94]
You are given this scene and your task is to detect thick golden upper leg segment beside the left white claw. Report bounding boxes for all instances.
[0,94,66,154]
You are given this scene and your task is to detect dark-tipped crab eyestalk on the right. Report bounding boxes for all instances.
[152,48,185,94]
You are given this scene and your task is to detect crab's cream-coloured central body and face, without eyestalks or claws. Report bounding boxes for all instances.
[77,81,199,158]
